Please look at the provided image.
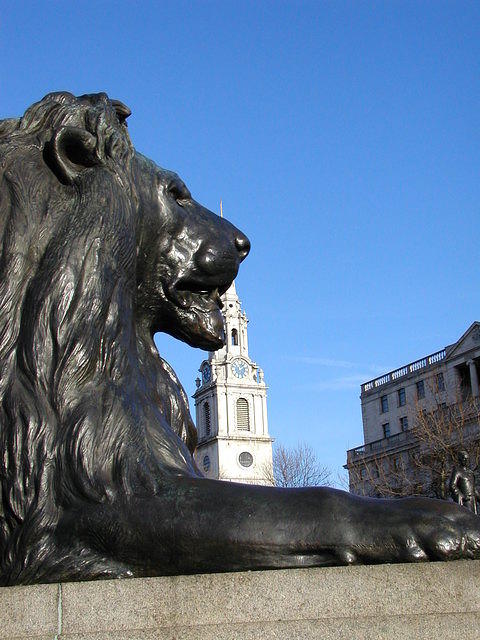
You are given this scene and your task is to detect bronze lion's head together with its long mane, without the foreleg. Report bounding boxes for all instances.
[0,92,249,580]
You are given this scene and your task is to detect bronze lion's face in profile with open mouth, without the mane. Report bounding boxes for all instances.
[133,154,250,350]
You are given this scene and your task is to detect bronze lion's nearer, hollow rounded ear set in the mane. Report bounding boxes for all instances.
[45,127,99,184]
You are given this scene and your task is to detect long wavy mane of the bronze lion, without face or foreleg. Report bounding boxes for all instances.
[0,92,199,584]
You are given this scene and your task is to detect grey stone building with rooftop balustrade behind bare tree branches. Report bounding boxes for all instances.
[345,322,480,495]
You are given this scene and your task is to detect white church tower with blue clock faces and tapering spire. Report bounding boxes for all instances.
[193,283,272,484]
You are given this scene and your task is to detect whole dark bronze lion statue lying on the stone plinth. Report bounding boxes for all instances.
[0,92,480,585]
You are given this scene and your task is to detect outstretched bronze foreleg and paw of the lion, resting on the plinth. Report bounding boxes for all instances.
[54,478,480,576]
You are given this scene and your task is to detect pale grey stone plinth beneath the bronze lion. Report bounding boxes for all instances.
[0,561,480,640]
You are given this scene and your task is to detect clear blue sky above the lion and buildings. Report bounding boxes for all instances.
[0,0,480,480]
